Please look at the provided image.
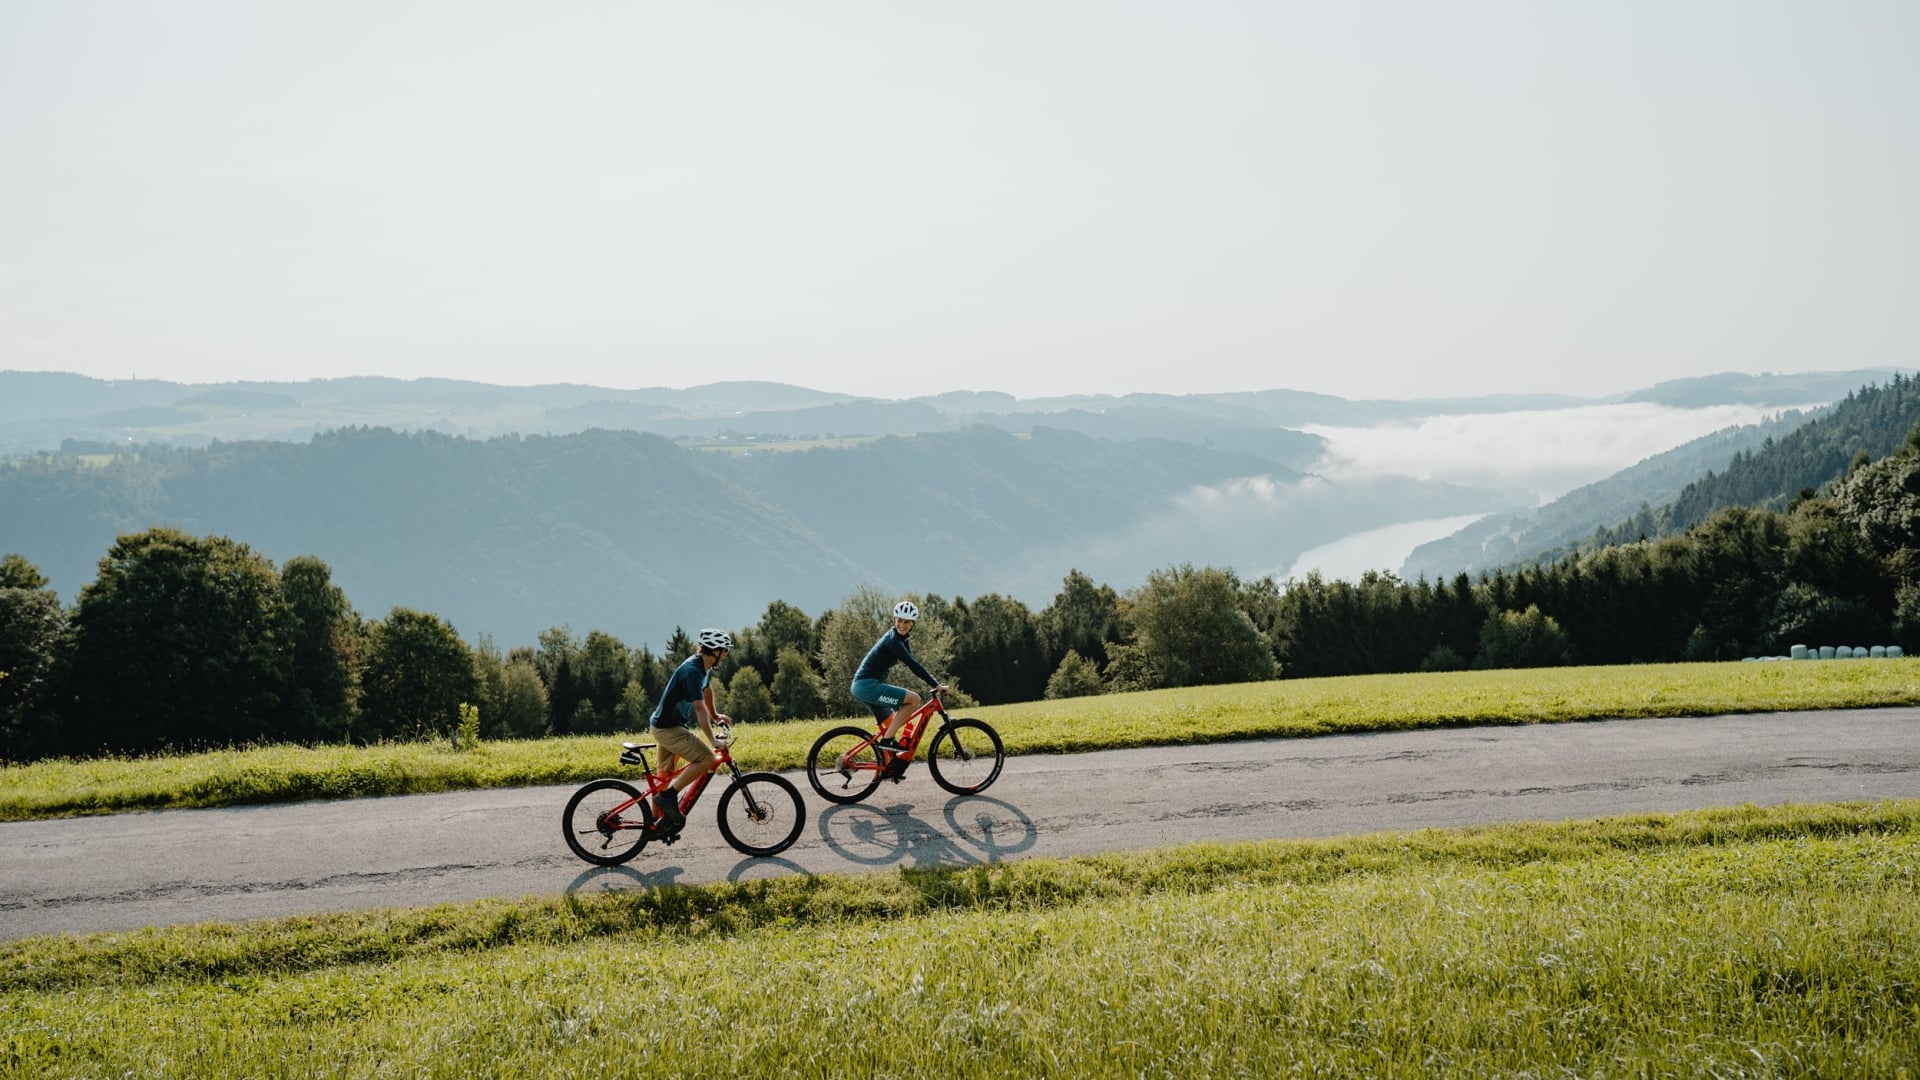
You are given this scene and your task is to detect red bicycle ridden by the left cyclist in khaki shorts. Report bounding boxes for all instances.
[561,724,806,867]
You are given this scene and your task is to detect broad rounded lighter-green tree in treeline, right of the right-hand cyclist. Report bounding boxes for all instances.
[1129,563,1277,686]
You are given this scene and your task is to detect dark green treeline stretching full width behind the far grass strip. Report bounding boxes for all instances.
[11,420,1920,759]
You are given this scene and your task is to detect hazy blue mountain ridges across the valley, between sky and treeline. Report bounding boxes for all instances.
[0,369,1897,642]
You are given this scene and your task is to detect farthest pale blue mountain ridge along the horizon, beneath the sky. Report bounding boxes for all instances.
[0,369,1895,455]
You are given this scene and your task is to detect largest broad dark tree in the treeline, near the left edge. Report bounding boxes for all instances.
[67,528,295,751]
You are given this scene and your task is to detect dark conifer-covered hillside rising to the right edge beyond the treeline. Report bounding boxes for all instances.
[1538,375,1920,563]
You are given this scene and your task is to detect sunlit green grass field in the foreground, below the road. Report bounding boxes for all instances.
[0,801,1920,1078]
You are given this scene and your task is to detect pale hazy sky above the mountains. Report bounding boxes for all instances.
[0,0,1920,398]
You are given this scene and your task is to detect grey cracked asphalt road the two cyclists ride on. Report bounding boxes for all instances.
[0,709,1920,940]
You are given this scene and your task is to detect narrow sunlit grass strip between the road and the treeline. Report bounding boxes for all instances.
[0,659,1920,821]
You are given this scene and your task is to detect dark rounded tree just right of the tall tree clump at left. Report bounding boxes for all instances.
[355,607,476,740]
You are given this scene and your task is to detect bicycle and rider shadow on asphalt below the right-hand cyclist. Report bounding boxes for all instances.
[818,796,1041,867]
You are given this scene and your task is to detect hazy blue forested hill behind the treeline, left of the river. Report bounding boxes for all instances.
[0,427,1492,644]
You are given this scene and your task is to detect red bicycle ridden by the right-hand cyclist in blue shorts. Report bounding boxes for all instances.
[806,690,1006,803]
